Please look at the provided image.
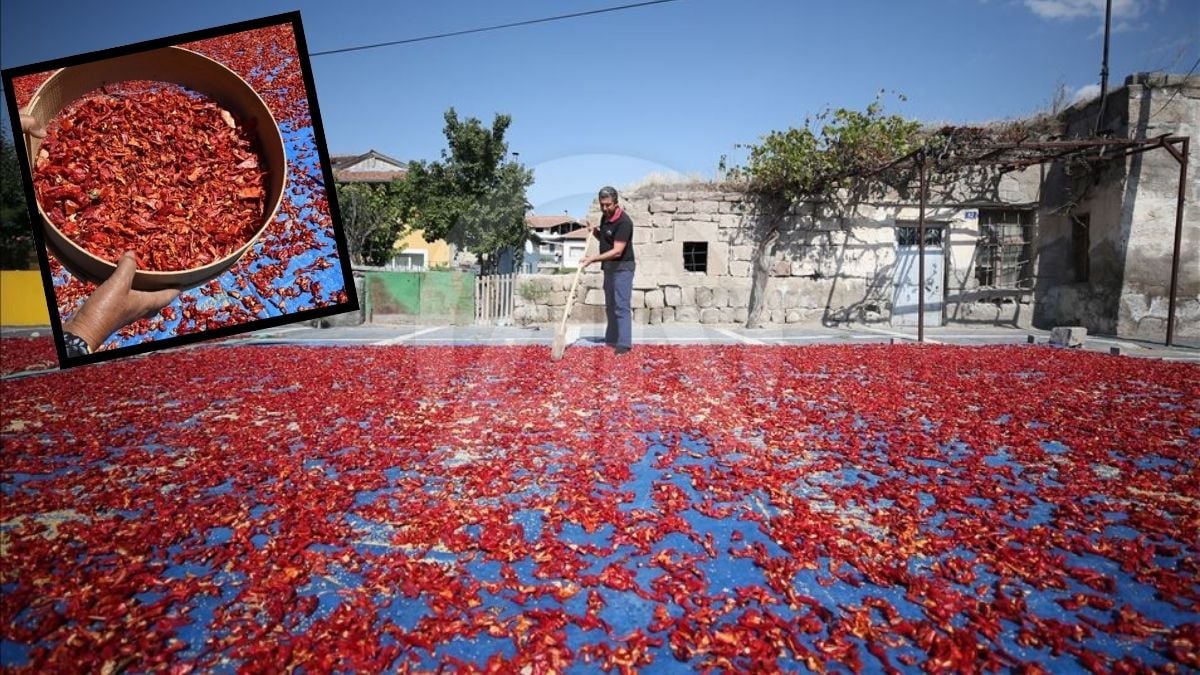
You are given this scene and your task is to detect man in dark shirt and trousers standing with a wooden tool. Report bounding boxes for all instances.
[581,187,635,354]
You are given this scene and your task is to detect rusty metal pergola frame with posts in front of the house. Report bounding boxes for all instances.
[863,127,1190,346]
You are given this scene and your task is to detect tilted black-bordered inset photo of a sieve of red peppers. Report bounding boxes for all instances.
[4,12,358,366]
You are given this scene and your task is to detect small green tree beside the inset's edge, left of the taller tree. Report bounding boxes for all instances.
[336,180,407,265]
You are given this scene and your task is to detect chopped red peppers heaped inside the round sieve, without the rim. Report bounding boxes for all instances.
[34,82,266,271]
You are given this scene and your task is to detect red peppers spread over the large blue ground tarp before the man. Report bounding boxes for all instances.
[0,346,1200,673]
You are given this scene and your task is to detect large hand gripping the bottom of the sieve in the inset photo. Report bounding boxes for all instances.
[62,251,179,351]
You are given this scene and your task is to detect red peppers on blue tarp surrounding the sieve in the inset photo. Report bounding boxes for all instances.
[13,25,348,348]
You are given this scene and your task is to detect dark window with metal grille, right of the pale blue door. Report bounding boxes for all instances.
[976,209,1033,288]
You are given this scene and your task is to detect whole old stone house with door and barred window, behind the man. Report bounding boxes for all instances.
[514,74,1200,342]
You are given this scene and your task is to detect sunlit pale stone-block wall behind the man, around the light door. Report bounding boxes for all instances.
[514,184,1036,325]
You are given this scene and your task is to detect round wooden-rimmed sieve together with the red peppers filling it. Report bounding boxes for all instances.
[23,47,287,289]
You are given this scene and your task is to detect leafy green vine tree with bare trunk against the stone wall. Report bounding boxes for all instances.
[721,98,920,328]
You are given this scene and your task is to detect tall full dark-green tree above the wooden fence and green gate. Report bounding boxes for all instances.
[397,108,533,270]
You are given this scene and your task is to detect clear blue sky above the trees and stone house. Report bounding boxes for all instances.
[0,0,1200,215]
